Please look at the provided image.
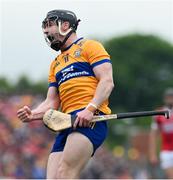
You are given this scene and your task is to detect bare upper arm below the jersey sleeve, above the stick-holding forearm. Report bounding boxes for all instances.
[93,62,113,82]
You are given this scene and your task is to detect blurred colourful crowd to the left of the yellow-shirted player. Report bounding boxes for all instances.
[0,95,54,179]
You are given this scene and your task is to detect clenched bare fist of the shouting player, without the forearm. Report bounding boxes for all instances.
[17,106,32,122]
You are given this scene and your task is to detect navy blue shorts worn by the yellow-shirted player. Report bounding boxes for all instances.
[51,109,107,155]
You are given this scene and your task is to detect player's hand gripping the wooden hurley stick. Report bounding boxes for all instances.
[73,109,94,128]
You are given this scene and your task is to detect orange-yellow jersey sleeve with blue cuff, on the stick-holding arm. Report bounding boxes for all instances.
[84,40,111,68]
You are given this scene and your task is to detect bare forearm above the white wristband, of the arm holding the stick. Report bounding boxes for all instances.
[91,78,114,107]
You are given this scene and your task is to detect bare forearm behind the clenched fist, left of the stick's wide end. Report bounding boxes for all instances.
[32,100,59,121]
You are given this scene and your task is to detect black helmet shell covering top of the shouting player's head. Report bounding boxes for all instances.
[43,10,80,30]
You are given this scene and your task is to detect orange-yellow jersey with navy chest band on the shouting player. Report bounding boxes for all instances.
[49,38,111,114]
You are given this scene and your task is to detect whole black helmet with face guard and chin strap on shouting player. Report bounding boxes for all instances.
[42,10,79,51]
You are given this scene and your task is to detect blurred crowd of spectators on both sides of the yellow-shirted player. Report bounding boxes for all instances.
[0,95,164,179]
